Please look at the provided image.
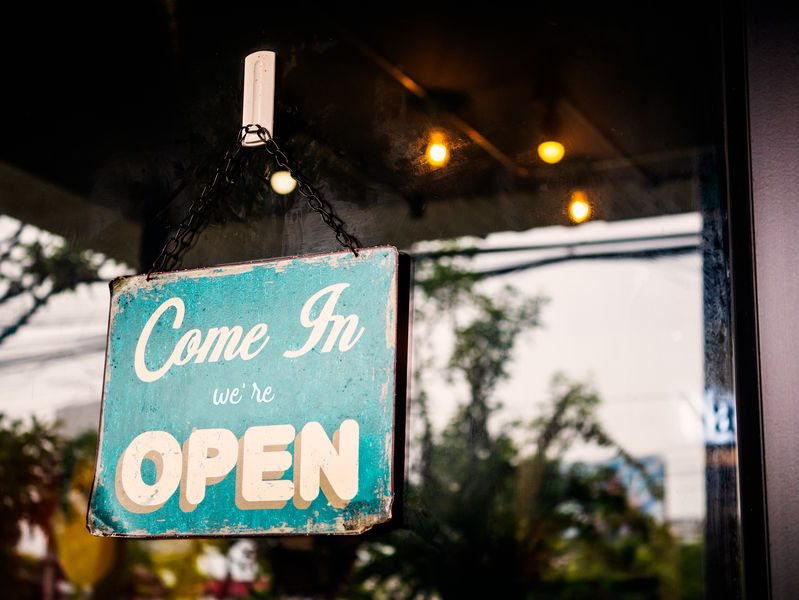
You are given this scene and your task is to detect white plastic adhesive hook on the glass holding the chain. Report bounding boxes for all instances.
[241,50,275,146]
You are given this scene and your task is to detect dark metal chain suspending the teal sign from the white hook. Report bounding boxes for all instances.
[147,125,360,281]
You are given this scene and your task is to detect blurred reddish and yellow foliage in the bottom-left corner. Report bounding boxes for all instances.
[0,415,227,599]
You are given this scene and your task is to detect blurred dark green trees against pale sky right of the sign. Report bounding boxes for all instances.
[348,253,676,599]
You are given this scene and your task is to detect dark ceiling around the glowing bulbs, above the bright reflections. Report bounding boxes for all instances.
[0,0,721,265]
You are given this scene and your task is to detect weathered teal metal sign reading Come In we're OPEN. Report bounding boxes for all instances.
[87,246,408,537]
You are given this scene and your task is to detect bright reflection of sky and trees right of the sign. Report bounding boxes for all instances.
[352,214,704,598]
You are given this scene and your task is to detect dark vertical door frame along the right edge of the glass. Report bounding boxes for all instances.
[722,1,799,599]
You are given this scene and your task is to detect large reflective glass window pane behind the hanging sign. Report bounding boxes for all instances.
[0,2,741,599]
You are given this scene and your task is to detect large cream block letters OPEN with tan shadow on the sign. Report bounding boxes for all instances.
[115,419,359,513]
